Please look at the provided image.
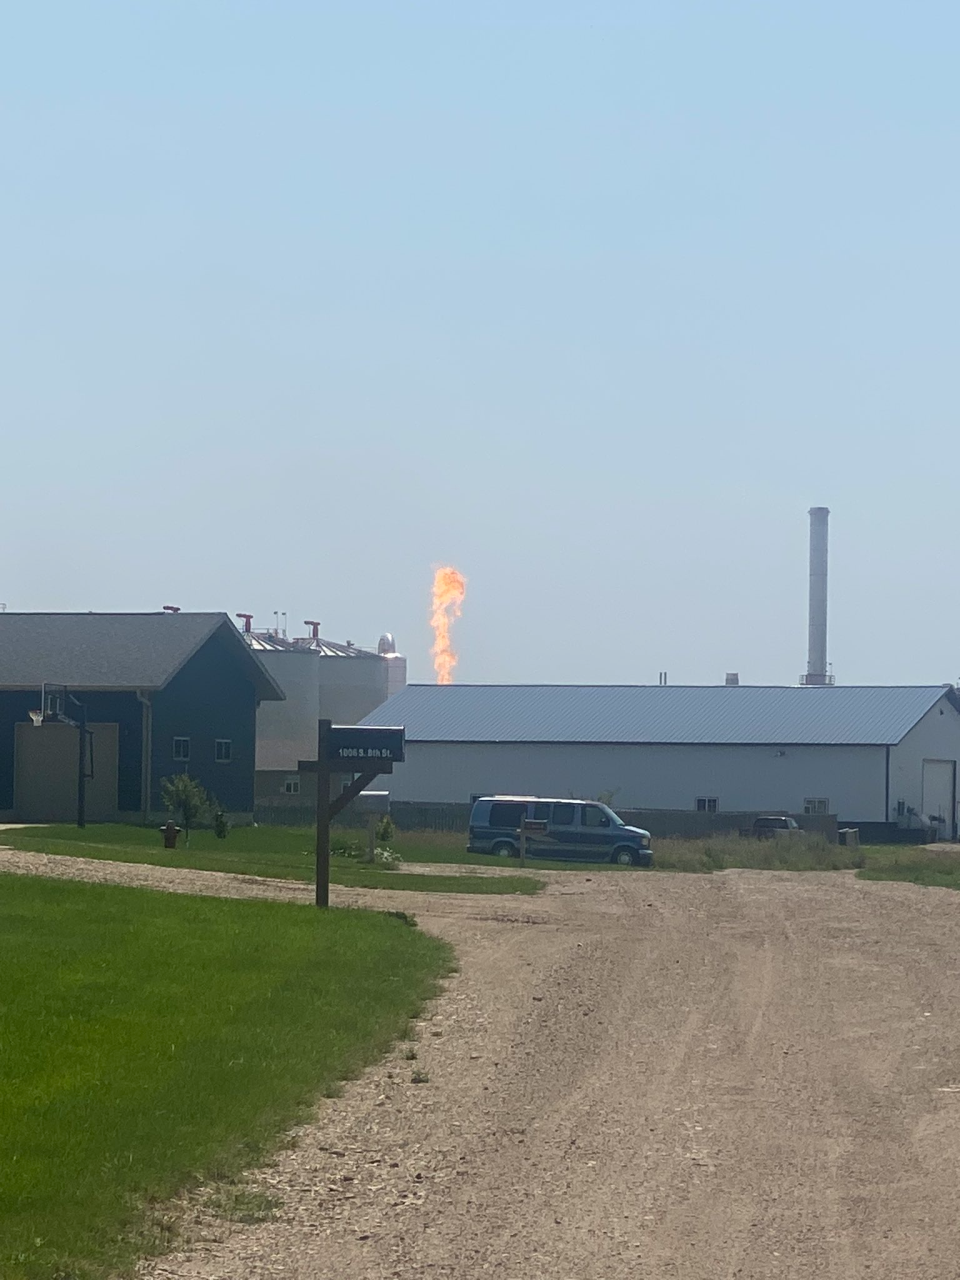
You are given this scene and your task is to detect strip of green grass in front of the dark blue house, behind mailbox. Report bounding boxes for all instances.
[0,823,543,893]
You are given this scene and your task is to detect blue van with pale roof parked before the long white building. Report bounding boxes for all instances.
[467,796,653,867]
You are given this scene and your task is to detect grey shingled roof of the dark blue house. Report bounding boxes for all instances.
[0,613,283,701]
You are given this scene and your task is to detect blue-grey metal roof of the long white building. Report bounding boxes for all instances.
[361,685,946,746]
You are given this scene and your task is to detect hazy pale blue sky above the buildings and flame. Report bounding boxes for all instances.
[0,0,960,684]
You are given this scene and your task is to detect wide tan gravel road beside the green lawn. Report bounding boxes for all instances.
[1,855,960,1280]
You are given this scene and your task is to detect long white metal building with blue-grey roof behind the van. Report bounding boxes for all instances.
[362,685,960,840]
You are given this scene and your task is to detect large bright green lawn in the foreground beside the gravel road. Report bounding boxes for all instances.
[0,876,452,1280]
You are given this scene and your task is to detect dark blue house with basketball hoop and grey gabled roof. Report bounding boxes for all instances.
[0,613,283,822]
